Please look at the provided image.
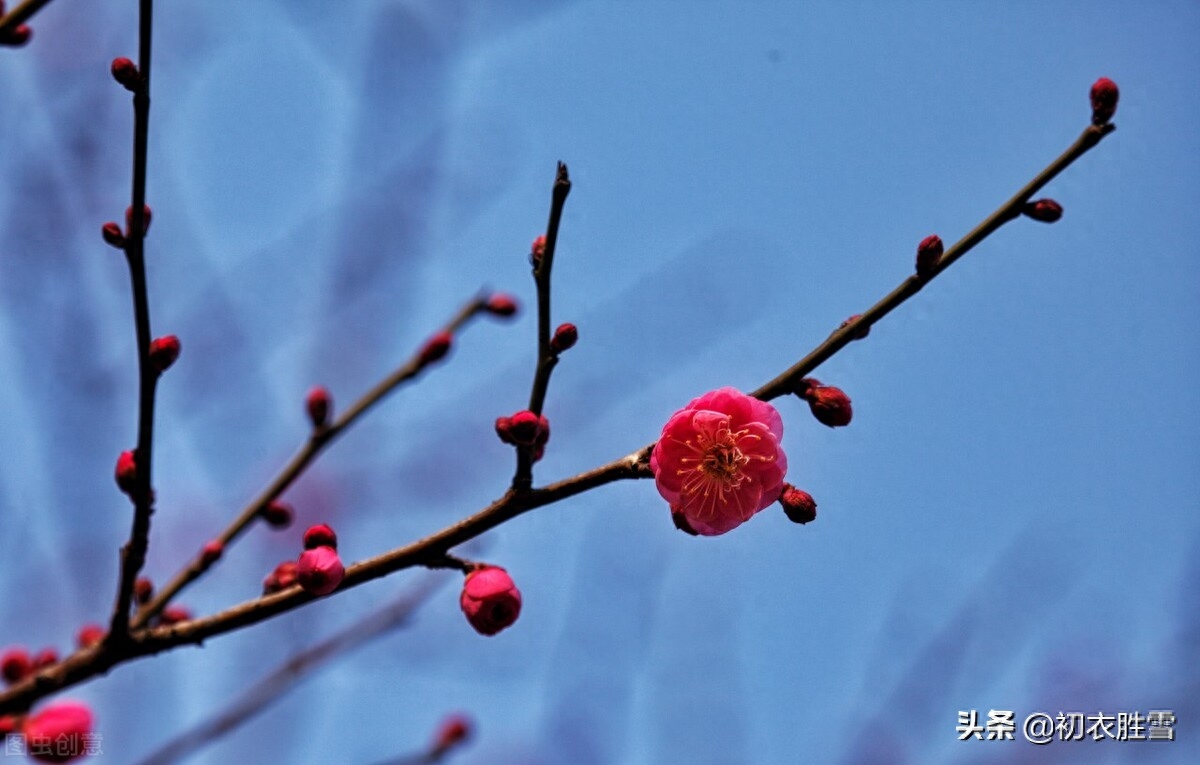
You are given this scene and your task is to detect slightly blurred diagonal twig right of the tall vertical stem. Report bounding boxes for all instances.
[133,294,487,630]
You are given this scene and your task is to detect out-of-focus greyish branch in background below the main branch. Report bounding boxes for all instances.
[140,576,444,765]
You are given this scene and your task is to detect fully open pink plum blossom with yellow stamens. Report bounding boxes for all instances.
[650,387,787,536]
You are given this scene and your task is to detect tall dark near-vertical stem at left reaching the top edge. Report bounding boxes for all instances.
[106,0,158,643]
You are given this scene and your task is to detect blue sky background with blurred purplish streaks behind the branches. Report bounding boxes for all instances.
[0,0,1200,765]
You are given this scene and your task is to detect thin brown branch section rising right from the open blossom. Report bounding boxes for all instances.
[751,124,1116,400]
